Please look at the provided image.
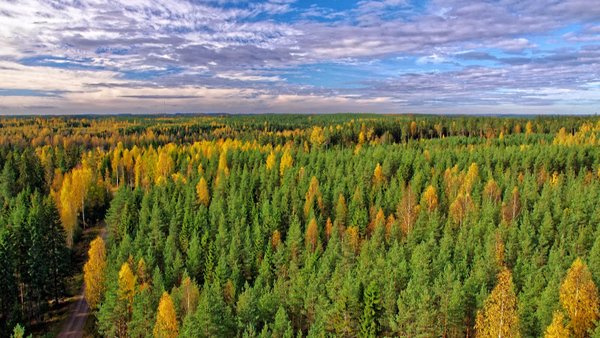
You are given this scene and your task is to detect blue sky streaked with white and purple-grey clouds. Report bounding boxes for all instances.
[0,0,600,115]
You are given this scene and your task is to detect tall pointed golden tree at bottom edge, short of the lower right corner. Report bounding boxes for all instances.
[475,268,521,338]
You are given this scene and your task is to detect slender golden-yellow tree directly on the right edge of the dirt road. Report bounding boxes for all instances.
[83,236,106,309]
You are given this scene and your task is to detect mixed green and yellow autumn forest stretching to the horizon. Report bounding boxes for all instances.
[0,114,600,338]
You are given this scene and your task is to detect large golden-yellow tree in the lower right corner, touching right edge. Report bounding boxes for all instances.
[560,258,600,337]
